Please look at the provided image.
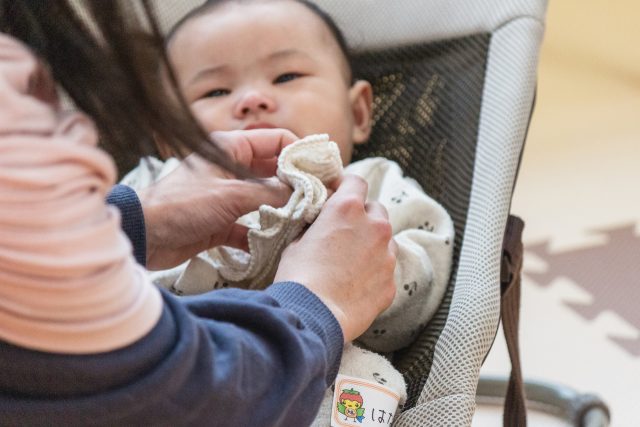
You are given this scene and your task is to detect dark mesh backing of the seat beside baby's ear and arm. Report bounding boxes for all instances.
[354,34,490,407]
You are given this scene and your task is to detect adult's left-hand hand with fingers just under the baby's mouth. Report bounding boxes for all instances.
[138,129,298,270]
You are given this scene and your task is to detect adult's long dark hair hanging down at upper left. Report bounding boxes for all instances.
[0,0,240,176]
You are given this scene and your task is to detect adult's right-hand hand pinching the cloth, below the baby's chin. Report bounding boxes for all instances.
[275,175,397,341]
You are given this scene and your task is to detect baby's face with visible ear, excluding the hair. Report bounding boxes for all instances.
[169,1,371,164]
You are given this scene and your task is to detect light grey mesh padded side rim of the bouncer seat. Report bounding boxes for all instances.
[418,17,543,412]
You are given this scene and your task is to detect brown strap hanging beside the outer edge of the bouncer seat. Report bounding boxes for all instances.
[500,215,527,427]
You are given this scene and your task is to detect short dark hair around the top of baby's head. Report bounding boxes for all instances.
[166,0,353,83]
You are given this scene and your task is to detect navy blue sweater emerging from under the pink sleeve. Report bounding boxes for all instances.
[0,186,343,427]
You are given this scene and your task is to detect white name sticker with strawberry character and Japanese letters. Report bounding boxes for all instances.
[331,374,400,427]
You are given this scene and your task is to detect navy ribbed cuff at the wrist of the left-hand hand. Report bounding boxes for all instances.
[107,184,147,265]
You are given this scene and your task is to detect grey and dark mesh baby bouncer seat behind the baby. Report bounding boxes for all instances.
[129,0,600,426]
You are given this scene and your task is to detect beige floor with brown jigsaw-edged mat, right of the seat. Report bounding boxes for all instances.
[474,0,640,427]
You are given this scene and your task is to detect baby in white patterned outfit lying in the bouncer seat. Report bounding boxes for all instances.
[123,0,454,426]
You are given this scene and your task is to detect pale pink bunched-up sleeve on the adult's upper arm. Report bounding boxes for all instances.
[0,34,162,353]
